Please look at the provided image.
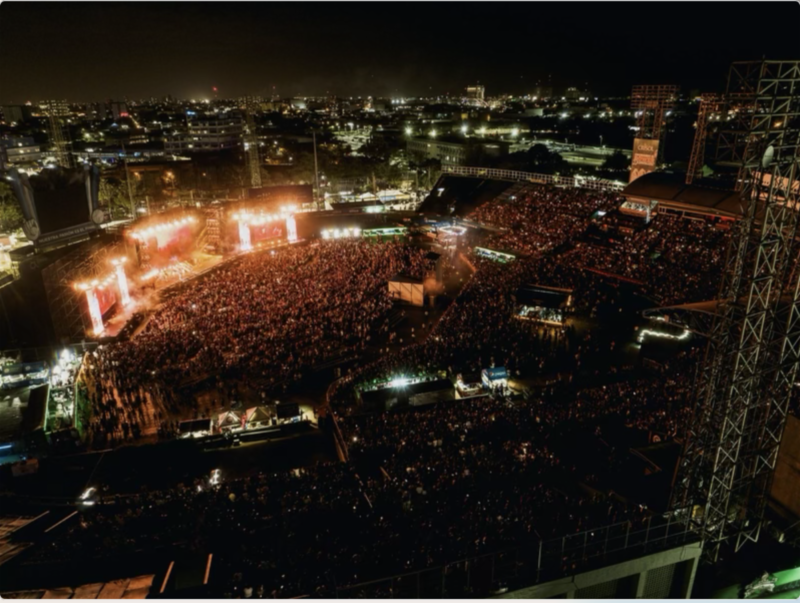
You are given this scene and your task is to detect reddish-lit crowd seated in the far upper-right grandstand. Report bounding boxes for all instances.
[471,187,729,304]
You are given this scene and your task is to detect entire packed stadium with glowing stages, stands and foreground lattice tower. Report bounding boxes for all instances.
[0,50,800,598]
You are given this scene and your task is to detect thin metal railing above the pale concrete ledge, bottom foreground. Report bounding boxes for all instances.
[336,511,700,598]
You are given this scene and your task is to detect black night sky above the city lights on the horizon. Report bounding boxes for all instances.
[0,2,800,103]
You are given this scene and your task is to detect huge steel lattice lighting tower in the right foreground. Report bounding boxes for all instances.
[673,61,800,562]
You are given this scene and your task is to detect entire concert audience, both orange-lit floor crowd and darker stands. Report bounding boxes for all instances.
[26,188,726,597]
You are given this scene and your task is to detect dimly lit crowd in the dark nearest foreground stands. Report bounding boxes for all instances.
[35,370,692,597]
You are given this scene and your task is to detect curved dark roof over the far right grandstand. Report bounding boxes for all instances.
[622,172,741,218]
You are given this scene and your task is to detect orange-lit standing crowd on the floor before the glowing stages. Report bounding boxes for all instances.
[80,240,424,440]
